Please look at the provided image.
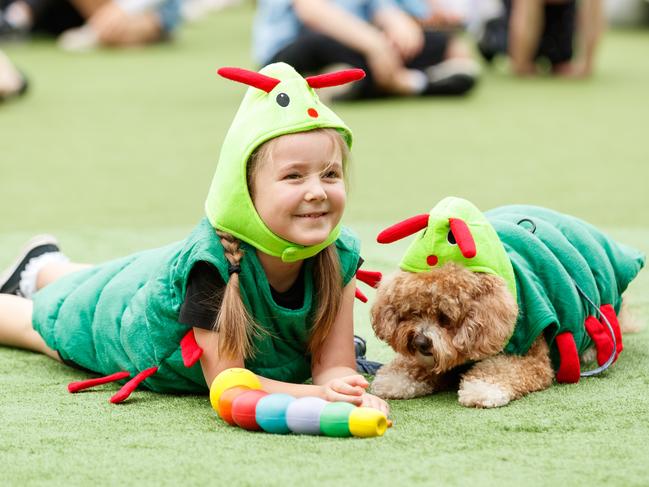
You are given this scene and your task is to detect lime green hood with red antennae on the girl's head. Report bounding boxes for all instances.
[205,63,364,262]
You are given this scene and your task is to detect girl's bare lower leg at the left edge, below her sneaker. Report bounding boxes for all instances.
[0,294,60,361]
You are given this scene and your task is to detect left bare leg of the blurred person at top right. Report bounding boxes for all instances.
[508,0,544,76]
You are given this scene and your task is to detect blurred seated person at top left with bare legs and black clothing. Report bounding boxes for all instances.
[0,0,180,50]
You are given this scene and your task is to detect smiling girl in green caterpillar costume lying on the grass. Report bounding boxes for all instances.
[0,64,388,413]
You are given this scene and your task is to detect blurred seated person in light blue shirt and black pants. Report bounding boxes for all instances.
[253,0,479,99]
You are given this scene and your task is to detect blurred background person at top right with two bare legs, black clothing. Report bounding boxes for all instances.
[478,0,606,77]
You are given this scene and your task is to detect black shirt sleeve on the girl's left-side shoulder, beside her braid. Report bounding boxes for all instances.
[178,261,225,330]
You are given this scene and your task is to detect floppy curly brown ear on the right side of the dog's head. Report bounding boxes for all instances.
[453,274,518,360]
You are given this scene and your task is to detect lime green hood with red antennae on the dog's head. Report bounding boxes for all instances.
[378,196,516,298]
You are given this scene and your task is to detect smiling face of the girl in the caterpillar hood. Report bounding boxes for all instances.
[250,130,346,246]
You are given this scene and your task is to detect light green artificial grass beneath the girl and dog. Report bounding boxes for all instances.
[0,4,649,486]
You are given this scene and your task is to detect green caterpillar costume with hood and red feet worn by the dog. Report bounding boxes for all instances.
[378,197,645,382]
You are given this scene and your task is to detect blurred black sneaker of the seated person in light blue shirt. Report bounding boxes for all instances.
[424,58,480,95]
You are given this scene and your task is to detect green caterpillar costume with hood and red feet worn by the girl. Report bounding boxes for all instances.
[32,63,372,403]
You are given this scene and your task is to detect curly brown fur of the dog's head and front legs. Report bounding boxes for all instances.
[372,263,632,408]
